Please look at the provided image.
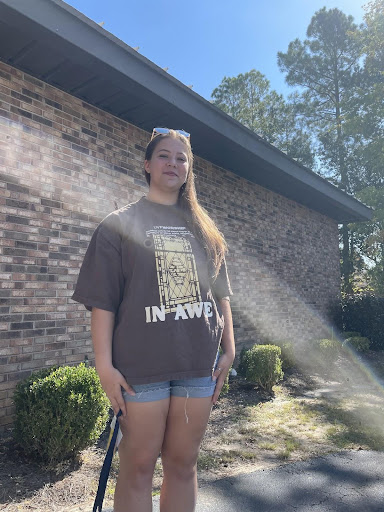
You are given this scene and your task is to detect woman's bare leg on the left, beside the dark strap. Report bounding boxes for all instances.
[114,398,170,512]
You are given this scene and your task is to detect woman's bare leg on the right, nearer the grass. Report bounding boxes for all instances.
[160,396,212,512]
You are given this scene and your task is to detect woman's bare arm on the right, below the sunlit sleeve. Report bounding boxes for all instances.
[212,299,235,404]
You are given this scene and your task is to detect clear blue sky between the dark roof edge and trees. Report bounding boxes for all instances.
[66,0,368,99]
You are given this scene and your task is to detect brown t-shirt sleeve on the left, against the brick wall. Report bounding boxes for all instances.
[72,214,124,313]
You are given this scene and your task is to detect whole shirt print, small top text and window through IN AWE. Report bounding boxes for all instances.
[145,226,212,323]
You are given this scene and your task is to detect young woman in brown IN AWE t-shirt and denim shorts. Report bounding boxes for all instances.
[72,128,235,512]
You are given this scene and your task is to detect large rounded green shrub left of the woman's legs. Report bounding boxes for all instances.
[14,363,109,464]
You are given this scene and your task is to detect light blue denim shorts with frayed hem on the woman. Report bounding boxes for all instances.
[122,376,216,402]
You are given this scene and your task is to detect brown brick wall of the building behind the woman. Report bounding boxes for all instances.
[0,63,340,427]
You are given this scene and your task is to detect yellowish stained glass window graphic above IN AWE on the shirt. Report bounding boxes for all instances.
[153,234,201,313]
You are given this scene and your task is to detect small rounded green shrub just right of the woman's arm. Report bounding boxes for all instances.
[243,345,284,392]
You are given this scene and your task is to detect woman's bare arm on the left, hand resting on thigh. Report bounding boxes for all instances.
[91,308,135,416]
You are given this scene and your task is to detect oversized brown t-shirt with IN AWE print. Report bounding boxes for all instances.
[72,197,232,384]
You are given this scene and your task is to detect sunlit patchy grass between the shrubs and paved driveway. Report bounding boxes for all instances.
[201,356,384,471]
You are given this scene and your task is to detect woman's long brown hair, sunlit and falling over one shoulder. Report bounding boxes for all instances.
[144,130,227,277]
